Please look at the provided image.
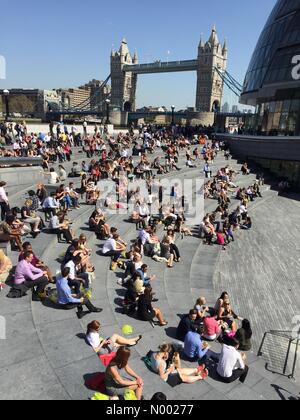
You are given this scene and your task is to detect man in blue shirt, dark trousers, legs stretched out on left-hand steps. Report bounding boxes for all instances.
[56,267,102,319]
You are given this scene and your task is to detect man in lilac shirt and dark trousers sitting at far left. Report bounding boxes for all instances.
[15,251,49,302]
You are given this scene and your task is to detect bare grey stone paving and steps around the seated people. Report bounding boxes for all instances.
[0,144,300,400]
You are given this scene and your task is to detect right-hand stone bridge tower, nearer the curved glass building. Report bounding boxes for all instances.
[196,27,228,112]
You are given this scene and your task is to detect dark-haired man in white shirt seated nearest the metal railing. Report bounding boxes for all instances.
[217,338,249,384]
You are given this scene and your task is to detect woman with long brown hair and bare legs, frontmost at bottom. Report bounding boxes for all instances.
[105,347,144,401]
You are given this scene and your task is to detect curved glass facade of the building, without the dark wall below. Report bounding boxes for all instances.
[241,0,300,136]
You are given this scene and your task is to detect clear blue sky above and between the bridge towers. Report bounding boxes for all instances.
[0,0,276,108]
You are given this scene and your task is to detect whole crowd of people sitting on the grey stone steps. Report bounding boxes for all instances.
[0,125,261,400]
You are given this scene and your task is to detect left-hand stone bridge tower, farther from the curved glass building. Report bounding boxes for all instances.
[111,39,138,111]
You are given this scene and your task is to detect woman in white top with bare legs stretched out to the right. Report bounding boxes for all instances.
[86,321,142,354]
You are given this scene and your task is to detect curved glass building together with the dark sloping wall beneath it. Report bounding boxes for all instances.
[221,0,300,189]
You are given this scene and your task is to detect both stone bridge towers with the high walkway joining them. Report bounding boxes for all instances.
[111,27,228,113]
